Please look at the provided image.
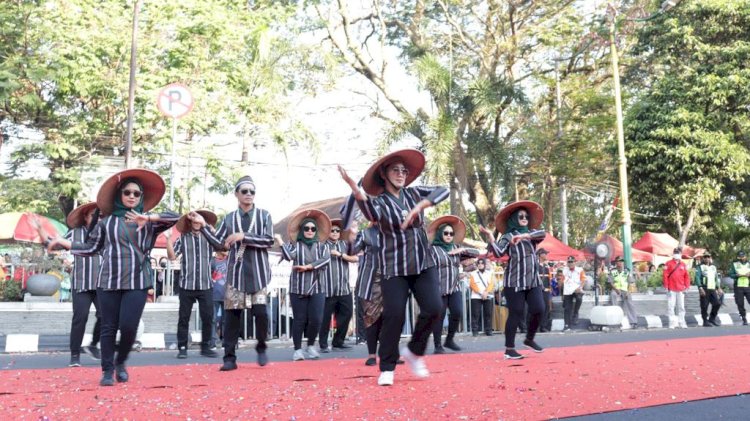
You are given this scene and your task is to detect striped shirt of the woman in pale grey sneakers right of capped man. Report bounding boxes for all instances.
[281,241,331,295]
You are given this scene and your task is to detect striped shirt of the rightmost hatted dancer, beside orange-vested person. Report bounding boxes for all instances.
[487,230,547,291]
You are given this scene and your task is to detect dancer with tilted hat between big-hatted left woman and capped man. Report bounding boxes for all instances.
[164,210,218,359]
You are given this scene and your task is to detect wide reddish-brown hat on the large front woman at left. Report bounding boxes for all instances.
[96,168,166,215]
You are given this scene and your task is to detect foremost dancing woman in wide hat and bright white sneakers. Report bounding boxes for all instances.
[339,149,448,386]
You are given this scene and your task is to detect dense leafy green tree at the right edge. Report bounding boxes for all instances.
[626,0,750,245]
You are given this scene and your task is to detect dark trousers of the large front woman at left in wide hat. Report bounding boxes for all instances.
[97,289,148,371]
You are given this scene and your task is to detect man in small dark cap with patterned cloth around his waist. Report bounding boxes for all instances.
[189,176,274,371]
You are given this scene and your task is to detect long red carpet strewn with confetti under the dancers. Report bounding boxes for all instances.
[0,335,750,420]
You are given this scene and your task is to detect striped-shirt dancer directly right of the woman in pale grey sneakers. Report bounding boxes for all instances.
[319,218,358,352]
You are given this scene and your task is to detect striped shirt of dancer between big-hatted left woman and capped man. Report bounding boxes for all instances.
[174,232,213,291]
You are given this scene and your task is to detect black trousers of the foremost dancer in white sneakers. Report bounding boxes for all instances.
[378,266,442,371]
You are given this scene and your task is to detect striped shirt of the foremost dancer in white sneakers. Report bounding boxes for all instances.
[357,186,449,279]
